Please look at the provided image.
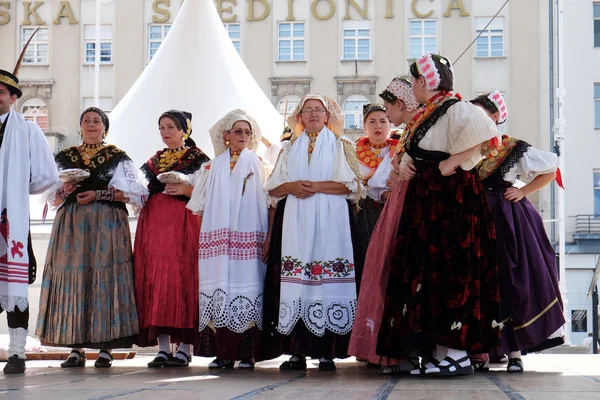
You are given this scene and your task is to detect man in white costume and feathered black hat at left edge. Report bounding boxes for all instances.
[0,42,58,374]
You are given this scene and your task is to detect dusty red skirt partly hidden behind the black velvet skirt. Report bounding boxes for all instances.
[348,182,408,366]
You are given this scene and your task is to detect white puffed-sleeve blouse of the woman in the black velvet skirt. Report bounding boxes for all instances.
[402,101,500,171]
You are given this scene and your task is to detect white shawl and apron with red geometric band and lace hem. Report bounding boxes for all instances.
[187,149,269,333]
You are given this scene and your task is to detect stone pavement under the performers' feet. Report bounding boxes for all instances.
[0,354,600,400]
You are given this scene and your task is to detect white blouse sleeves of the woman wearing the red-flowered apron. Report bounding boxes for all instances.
[265,137,364,207]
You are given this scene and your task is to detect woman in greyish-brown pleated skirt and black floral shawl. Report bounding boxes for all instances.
[36,107,148,368]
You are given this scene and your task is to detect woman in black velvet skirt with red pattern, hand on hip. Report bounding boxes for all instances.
[377,54,500,376]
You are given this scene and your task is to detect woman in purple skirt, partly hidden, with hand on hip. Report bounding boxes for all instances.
[471,91,565,372]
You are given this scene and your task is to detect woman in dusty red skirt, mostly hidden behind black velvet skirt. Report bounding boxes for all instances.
[348,78,419,373]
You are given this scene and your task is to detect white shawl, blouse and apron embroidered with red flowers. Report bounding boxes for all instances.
[265,128,362,336]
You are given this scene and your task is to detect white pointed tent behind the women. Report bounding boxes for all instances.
[109,0,283,165]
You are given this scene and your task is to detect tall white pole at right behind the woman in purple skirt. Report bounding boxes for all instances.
[554,0,571,345]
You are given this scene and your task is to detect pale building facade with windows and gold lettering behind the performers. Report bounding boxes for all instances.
[5,0,600,344]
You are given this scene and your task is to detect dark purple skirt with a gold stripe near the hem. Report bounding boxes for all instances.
[487,189,565,353]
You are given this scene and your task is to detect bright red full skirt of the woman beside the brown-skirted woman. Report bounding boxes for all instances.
[134,193,200,346]
